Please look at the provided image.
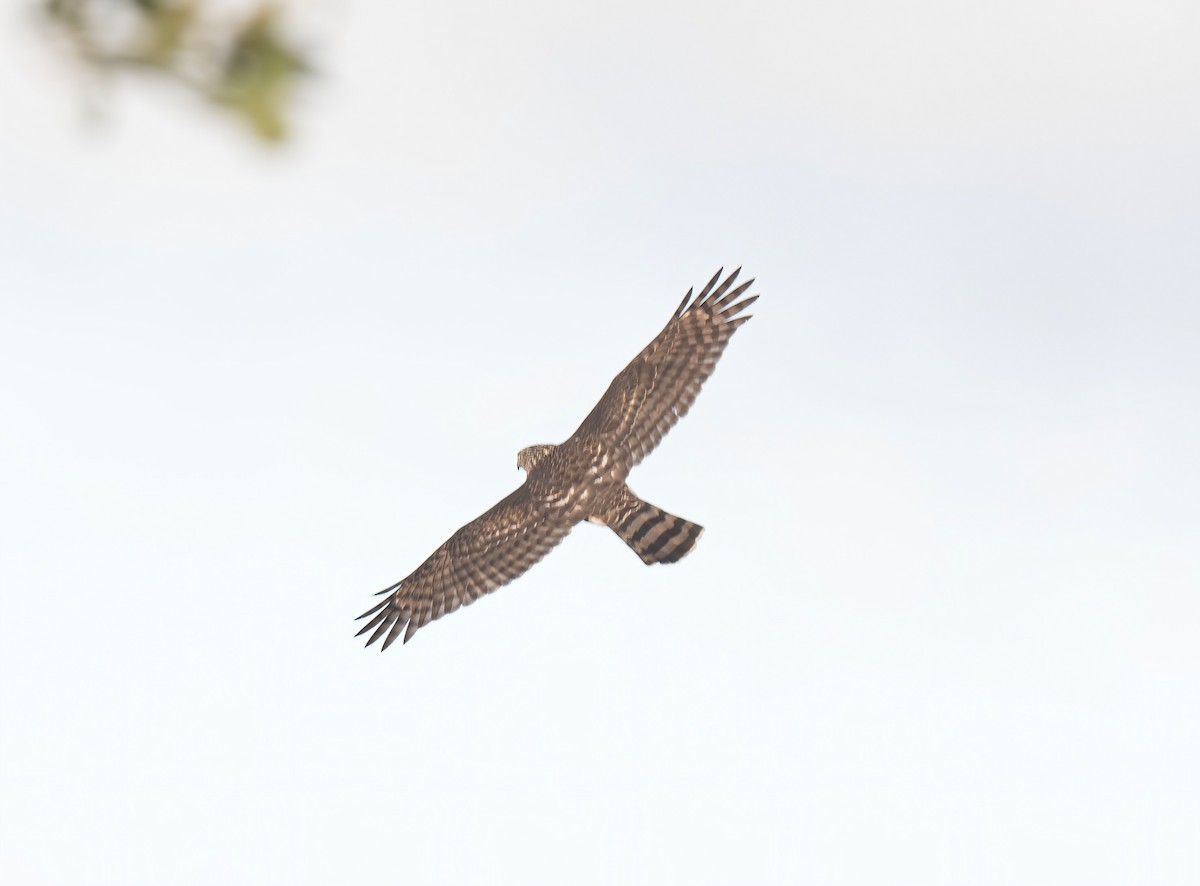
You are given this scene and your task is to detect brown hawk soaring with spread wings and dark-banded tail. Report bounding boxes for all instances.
[359,268,758,649]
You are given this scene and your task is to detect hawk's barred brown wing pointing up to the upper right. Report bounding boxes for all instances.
[575,268,758,465]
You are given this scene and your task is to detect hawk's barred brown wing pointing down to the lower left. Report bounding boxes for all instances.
[359,485,571,649]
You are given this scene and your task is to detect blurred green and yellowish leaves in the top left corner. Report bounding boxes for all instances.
[42,0,311,142]
